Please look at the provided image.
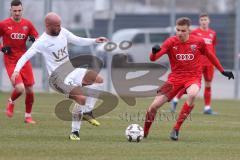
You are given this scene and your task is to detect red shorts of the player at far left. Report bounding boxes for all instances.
[5,61,34,86]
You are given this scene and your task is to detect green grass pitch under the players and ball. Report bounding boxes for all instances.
[0,93,240,160]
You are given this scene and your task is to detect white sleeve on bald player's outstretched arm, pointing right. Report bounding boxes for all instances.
[62,28,96,46]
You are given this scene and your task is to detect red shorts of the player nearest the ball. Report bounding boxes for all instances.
[158,78,201,102]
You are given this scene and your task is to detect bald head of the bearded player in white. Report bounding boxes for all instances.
[45,12,61,36]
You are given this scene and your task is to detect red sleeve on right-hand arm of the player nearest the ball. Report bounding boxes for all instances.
[201,41,224,72]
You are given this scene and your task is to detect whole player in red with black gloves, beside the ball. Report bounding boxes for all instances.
[144,17,234,140]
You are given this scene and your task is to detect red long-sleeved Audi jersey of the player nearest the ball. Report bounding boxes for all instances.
[150,35,223,80]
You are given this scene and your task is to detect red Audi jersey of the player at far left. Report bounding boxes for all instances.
[0,18,38,63]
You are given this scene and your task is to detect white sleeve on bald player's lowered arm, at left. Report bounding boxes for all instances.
[14,45,39,72]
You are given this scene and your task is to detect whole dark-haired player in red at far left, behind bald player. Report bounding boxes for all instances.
[0,0,38,123]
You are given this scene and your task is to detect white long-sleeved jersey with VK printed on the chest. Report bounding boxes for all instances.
[14,28,96,75]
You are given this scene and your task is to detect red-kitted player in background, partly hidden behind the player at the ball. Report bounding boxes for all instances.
[171,13,217,114]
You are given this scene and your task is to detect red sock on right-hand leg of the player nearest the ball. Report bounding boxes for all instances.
[174,102,194,131]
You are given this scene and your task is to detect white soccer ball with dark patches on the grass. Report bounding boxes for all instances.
[125,124,144,142]
